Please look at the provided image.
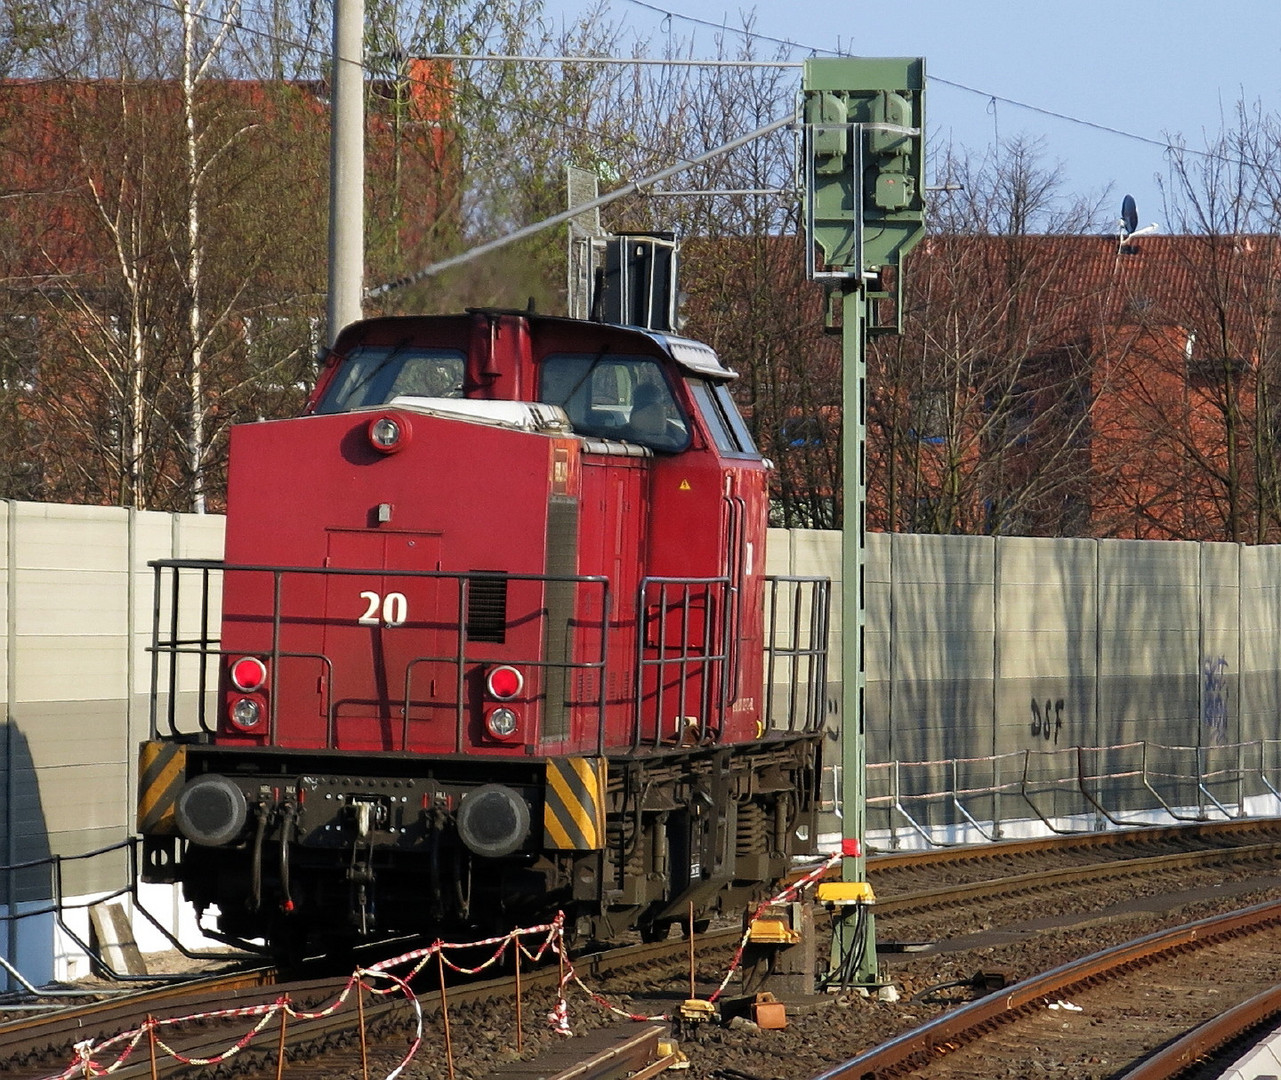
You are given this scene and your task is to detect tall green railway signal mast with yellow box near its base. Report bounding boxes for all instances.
[802,58,925,986]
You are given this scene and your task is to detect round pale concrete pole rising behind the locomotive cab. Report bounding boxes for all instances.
[325,0,365,346]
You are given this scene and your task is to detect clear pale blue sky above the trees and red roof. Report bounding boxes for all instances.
[546,0,1281,231]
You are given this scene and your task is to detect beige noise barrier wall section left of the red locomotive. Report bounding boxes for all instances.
[0,501,223,984]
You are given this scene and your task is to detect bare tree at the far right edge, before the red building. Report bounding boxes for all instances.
[1122,102,1281,543]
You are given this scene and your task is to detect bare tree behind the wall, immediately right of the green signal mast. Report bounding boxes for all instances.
[869,140,1099,536]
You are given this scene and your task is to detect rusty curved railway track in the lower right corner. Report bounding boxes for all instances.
[822,902,1281,1080]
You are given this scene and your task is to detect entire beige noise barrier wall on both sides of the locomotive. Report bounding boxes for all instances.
[0,502,1281,978]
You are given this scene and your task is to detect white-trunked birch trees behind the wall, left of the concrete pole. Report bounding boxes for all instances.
[0,0,335,509]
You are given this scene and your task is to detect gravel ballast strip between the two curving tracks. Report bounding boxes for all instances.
[375,871,1281,1080]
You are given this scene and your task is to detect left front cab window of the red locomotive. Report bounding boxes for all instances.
[315,345,465,413]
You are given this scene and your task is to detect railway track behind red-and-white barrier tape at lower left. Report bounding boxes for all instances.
[0,930,738,1080]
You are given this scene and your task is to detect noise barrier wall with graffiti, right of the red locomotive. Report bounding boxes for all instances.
[770,532,1281,835]
